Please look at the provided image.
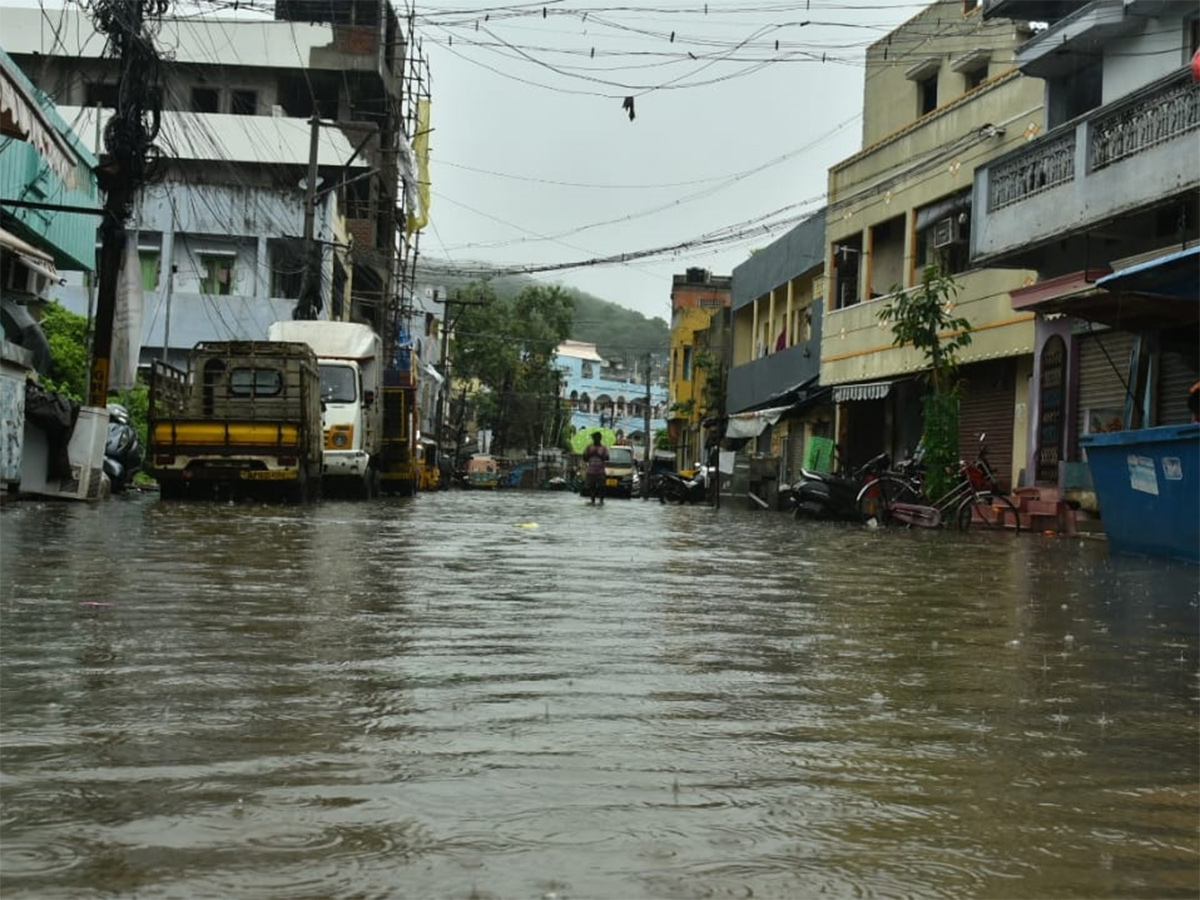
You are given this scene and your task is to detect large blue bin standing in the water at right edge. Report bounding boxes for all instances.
[1079,425,1200,563]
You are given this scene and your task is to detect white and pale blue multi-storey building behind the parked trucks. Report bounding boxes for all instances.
[2,0,422,361]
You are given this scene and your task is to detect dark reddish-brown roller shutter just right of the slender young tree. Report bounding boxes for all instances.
[959,359,1016,491]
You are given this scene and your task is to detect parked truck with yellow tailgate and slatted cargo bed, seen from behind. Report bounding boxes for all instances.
[146,341,322,503]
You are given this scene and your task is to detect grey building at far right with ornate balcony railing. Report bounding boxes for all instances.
[970,0,1200,501]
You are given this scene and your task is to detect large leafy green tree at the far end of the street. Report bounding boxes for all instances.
[451,282,575,455]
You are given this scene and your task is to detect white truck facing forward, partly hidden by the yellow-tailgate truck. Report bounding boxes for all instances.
[266,320,383,498]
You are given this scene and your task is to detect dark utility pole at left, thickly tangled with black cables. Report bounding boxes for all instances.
[88,0,168,407]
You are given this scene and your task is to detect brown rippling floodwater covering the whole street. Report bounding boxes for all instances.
[0,492,1200,900]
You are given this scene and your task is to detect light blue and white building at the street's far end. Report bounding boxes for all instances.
[556,341,667,444]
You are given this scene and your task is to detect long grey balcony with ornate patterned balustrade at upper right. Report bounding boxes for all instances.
[971,71,1200,265]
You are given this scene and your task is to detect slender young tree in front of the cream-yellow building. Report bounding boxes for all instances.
[880,265,971,498]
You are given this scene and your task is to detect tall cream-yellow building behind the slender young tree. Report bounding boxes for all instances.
[821,0,1045,494]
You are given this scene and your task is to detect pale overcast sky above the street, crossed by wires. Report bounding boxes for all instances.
[416,0,928,319]
